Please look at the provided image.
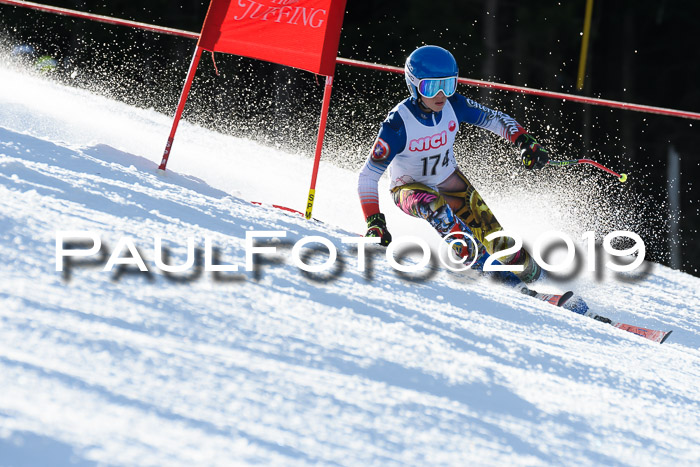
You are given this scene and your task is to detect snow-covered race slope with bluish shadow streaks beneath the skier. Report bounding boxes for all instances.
[0,67,700,465]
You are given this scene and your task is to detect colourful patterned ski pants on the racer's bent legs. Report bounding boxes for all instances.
[391,174,542,282]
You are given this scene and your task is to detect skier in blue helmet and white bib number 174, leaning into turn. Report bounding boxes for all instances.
[358,45,549,282]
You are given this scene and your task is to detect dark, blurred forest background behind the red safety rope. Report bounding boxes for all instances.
[0,0,700,275]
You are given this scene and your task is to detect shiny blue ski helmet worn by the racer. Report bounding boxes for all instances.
[404,45,459,99]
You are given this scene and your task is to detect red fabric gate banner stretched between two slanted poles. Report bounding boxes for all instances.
[199,0,346,76]
